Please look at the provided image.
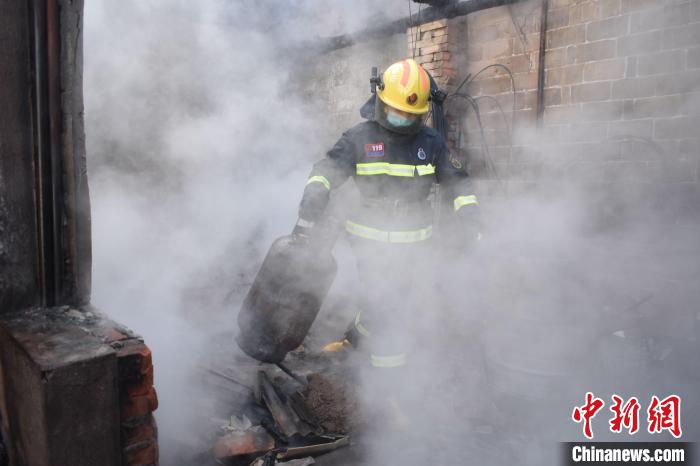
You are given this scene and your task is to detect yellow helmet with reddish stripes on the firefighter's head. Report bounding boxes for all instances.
[377,58,430,115]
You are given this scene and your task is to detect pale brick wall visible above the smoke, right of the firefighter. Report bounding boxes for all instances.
[409,0,700,195]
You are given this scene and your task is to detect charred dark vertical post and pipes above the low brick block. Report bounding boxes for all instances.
[29,0,90,306]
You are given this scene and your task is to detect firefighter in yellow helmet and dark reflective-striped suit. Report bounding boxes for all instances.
[293,59,478,368]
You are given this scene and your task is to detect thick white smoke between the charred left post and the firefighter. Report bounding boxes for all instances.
[84,0,401,464]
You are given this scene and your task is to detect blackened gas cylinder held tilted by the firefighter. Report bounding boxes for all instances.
[236,228,337,363]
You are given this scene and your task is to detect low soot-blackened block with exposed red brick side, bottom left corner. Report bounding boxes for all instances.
[0,306,158,466]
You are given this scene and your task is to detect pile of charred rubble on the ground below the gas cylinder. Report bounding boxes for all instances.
[202,352,358,466]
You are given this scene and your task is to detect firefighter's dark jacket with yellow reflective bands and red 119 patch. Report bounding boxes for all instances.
[299,121,477,242]
